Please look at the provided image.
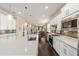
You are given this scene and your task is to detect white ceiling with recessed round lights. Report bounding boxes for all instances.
[0,3,64,26]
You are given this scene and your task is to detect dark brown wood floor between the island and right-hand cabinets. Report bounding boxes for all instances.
[38,40,58,56]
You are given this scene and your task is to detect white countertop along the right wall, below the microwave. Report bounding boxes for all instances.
[54,35,78,49]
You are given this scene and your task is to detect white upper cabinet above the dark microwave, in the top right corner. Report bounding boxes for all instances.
[61,3,79,17]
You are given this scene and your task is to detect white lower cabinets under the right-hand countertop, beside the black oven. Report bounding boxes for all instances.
[53,37,77,56]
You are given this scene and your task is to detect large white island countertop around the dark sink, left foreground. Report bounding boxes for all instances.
[0,34,38,56]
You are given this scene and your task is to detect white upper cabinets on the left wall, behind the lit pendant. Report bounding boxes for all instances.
[0,14,16,30]
